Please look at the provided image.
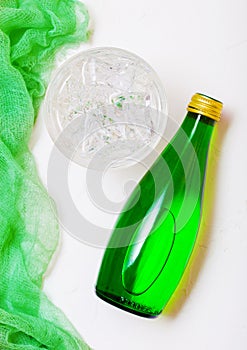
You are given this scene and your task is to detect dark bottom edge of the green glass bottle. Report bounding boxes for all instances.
[95,288,161,318]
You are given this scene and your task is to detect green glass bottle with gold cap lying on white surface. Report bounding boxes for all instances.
[96,94,223,317]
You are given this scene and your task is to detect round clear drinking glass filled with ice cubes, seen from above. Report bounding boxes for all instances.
[44,47,167,168]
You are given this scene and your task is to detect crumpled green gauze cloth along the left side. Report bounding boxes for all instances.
[0,0,89,350]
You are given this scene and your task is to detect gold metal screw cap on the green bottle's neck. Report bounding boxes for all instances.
[187,93,223,122]
